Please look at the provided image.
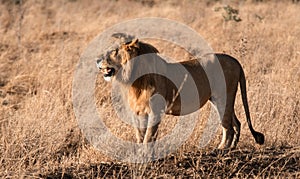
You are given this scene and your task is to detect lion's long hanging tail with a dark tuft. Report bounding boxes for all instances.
[240,68,265,145]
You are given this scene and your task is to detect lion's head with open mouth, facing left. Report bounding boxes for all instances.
[97,35,158,81]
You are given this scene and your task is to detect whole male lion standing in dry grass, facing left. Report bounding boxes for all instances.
[97,35,264,149]
